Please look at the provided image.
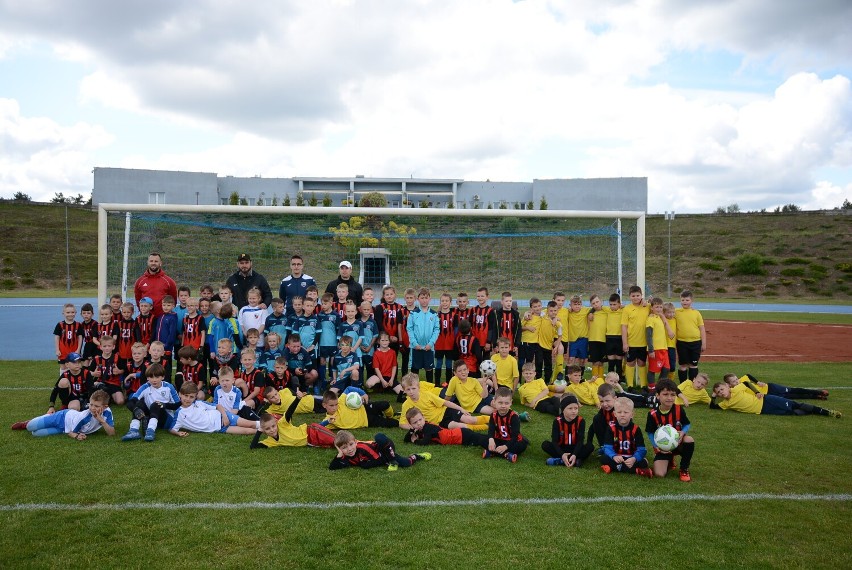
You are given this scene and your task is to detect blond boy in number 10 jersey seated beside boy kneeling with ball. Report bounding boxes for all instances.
[601,398,654,478]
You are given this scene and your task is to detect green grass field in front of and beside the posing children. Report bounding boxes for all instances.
[0,361,852,568]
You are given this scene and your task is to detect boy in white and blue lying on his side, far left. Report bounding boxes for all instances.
[12,390,115,441]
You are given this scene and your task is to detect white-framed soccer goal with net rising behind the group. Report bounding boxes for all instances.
[98,204,645,302]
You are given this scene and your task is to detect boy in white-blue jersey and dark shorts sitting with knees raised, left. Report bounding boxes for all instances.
[121,364,180,442]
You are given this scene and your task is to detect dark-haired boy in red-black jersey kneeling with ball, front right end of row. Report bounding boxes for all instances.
[645,378,695,483]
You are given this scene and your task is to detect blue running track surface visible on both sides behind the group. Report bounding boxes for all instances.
[0,297,852,360]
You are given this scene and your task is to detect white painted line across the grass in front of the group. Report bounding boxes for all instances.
[0,493,852,512]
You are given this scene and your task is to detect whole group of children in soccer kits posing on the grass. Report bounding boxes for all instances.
[18,278,840,472]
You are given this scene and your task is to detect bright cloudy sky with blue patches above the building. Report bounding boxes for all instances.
[0,0,852,213]
